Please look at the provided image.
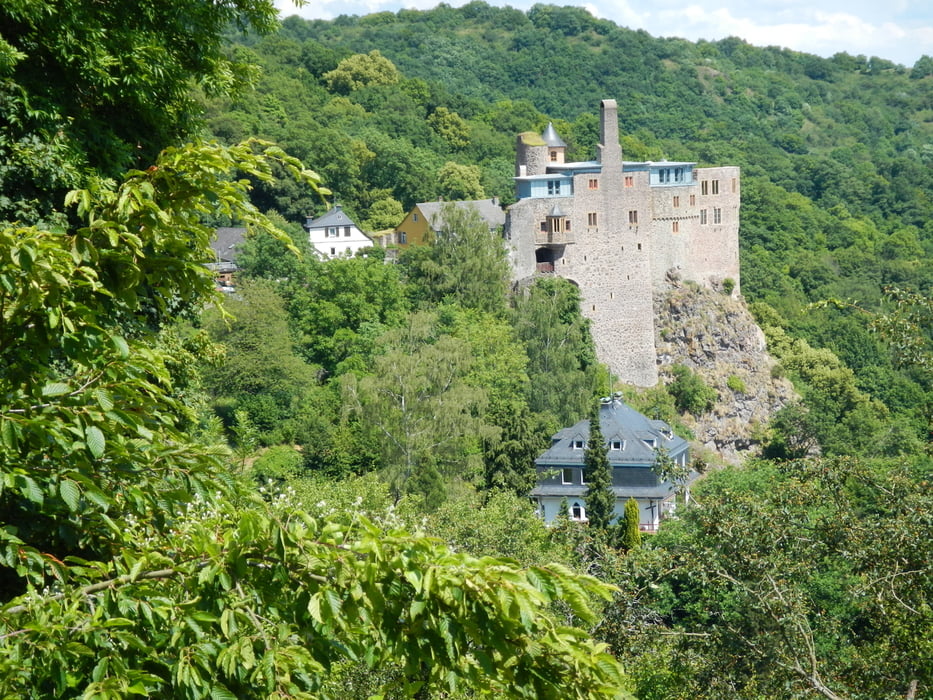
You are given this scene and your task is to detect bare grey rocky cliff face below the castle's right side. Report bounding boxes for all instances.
[654,282,796,462]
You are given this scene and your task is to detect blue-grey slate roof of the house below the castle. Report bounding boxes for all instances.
[535,398,688,467]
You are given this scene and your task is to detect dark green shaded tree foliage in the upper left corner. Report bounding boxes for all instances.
[0,0,276,221]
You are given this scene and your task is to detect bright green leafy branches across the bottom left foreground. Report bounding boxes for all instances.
[0,495,622,698]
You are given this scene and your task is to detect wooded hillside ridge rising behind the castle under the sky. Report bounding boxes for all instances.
[215,2,933,449]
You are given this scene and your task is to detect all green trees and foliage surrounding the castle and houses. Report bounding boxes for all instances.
[0,0,933,700]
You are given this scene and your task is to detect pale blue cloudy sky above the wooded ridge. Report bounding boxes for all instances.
[275,0,933,67]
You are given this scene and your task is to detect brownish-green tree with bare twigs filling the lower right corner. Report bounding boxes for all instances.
[605,458,933,698]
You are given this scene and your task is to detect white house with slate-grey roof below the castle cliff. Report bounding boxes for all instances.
[531,397,697,532]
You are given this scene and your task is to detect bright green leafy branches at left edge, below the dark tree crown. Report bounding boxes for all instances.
[0,143,316,594]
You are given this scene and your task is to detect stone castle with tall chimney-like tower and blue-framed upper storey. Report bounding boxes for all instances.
[505,100,741,386]
